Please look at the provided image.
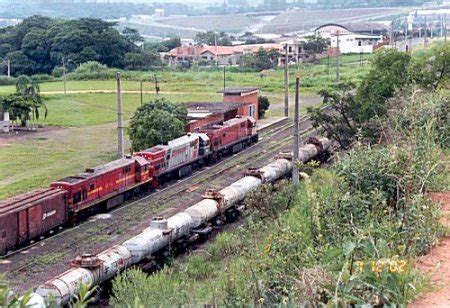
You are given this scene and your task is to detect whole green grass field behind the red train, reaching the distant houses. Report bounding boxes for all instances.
[0,59,368,200]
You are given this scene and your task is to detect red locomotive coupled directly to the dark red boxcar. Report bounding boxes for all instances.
[51,157,153,213]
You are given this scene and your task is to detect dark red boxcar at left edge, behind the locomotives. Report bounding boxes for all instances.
[0,188,67,254]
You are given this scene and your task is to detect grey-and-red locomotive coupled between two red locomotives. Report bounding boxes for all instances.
[134,133,210,182]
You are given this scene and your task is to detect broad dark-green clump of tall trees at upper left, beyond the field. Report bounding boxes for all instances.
[0,16,141,76]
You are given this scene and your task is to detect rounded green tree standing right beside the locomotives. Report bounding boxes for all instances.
[128,98,187,151]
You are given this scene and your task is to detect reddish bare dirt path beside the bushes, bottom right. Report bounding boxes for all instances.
[408,191,450,308]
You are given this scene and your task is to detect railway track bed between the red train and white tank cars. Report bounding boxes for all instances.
[0,113,322,291]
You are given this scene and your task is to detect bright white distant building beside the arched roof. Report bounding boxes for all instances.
[330,33,383,54]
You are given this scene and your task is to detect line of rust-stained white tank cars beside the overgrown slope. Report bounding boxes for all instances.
[32,138,331,306]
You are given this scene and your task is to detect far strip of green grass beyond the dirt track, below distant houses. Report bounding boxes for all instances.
[0,64,368,95]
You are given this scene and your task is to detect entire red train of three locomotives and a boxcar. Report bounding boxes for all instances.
[0,117,258,255]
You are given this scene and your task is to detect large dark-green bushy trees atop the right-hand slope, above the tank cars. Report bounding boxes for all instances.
[308,44,450,149]
